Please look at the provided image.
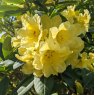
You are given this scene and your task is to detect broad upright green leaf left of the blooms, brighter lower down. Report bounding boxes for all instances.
[2,36,14,59]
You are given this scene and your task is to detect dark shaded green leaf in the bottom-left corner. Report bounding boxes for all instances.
[0,77,9,95]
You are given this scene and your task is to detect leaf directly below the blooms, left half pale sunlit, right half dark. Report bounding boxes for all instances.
[34,77,54,95]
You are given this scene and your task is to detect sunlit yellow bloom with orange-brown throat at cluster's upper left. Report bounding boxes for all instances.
[17,15,41,41]
